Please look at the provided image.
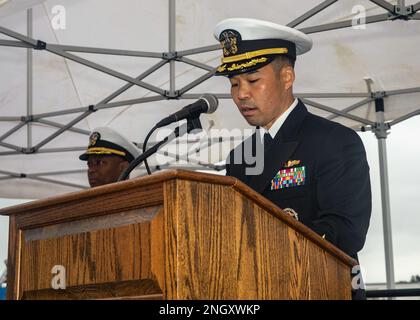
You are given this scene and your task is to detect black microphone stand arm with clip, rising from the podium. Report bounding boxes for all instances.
[118,117,203,181]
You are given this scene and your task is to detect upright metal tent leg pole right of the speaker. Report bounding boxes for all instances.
[375,98,395,289]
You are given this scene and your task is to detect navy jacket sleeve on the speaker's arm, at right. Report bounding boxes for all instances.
[309,126,372,256]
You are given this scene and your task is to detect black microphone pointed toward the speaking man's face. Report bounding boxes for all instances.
[156,94,219,128]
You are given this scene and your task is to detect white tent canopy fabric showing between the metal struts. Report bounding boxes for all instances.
[0,0,420,198]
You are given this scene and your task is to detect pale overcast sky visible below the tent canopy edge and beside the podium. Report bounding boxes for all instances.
[0,117,420,283]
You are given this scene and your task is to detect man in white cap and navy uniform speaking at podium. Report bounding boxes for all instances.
[214,18,371,298]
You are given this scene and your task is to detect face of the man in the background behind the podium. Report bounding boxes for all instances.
[87,155,129,188]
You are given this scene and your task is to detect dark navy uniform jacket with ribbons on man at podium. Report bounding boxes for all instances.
[226,101,371,259]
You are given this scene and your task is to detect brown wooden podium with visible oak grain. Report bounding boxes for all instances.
[0,170,357,299]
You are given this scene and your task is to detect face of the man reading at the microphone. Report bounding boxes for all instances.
[229,64,294,129]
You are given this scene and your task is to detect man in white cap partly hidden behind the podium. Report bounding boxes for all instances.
[79,127,140,187]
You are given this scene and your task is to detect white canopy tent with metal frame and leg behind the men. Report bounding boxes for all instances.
[0,0,420,287]
